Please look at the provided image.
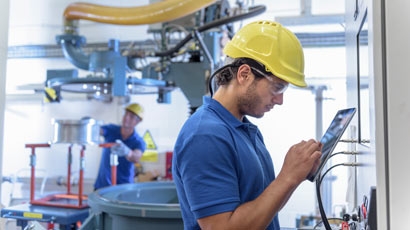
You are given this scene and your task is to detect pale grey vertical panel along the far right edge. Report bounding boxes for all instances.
[380,1,410,229]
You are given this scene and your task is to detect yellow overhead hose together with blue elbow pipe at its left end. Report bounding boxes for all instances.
[56,0,216,70]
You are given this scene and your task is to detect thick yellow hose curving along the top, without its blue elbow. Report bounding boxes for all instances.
[64,0,216,25]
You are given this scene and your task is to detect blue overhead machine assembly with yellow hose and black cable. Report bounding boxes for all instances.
[45,0,266,112]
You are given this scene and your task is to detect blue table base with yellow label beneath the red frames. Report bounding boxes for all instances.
[1,203,90,230]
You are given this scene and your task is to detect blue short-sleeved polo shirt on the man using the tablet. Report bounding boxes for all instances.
[172,96,280,230]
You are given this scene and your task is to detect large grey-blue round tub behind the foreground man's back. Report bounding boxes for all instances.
[82,182,184,230]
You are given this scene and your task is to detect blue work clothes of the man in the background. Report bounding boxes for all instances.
[94,124,146,189]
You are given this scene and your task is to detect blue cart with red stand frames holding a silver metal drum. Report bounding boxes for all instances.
[0,117,102,229]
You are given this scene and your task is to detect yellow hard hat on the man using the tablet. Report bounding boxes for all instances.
[223,21,307,87]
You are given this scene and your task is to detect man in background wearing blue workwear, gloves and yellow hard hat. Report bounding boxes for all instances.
[94,103,146,190]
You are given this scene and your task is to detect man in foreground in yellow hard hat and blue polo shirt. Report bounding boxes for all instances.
[172,21,321,230]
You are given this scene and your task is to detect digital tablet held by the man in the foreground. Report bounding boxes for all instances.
[307,108,356,182]
